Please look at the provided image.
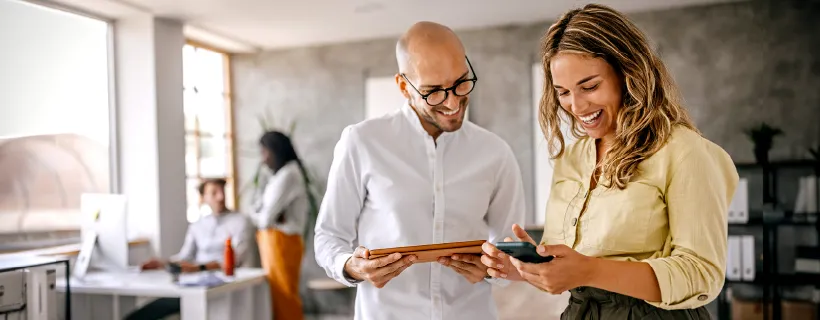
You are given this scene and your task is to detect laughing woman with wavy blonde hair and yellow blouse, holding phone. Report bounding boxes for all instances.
[482,5,738,319]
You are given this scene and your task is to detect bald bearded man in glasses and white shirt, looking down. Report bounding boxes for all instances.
[314,22,524,320]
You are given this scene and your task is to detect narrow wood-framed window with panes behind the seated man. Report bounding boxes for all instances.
[182,43,236,222]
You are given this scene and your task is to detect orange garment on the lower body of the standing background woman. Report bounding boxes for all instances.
[256,229,305,320]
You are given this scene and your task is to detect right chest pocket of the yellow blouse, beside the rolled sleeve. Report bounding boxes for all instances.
[583,182,666,254]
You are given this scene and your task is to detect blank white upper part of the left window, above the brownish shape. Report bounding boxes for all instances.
[0,0,109,146]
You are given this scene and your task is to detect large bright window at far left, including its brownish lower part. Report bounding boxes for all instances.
[0,0,113,242]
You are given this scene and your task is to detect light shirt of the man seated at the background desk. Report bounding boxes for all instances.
[172,212,256,266]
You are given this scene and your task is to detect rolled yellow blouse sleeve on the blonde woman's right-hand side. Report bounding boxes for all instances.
[644,141,738,310]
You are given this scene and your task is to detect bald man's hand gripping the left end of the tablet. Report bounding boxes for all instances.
[345,247,416,288]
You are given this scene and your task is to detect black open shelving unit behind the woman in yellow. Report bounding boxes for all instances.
[718,160,820,320]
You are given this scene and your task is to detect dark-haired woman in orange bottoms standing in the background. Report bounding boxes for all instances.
[254,131,310,320]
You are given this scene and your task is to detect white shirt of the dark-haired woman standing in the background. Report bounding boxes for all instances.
[254,161,309,235]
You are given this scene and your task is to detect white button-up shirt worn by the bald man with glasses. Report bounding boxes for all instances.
[315,103,525,320]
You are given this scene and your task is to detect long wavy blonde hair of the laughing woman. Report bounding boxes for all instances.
[539,4,699,189]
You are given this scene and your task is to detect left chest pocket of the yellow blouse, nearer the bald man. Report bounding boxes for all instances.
[544,180,582,244]
